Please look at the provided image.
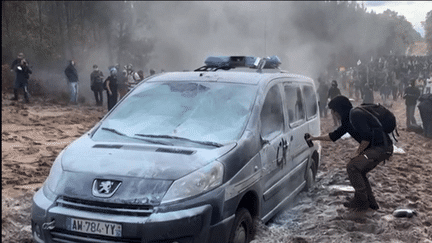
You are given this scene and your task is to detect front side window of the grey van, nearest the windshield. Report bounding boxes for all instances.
[260,85,284,138]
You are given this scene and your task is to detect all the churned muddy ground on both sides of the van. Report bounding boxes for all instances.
[2,91,432,243]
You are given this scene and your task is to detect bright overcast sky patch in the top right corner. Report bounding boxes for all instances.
[363,1,432,37]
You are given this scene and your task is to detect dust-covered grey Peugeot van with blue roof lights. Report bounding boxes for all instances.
[31,56,320,243]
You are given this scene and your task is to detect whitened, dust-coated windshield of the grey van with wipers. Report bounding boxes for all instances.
[93,81,257,146]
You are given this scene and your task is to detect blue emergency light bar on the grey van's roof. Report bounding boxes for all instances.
[194,56,281,72]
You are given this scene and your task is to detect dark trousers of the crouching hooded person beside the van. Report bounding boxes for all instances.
[347,146,393,197]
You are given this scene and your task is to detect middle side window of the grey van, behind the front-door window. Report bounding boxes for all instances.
[284,84,305,124]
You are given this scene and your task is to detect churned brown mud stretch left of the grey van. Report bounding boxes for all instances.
[2,99,104,243]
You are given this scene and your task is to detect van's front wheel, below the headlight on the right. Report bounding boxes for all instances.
[229,208,255,243]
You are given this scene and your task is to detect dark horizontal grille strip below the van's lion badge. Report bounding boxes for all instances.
[56,196,153,216]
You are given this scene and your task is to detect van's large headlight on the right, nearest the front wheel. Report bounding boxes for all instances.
[162,162,224,203]
